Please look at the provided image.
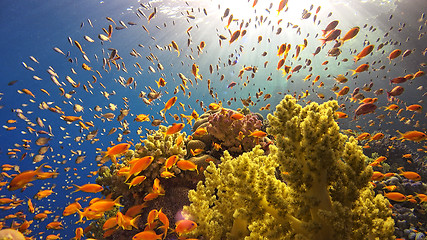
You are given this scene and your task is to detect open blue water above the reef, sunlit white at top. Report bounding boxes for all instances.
[0,0,427,239]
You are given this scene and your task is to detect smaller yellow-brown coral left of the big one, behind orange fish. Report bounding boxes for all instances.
[92,125,201,239]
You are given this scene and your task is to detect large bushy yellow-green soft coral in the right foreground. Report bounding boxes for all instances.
[184,96,394,240]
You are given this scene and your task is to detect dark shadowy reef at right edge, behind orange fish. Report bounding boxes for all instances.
[363,134,427,240]
